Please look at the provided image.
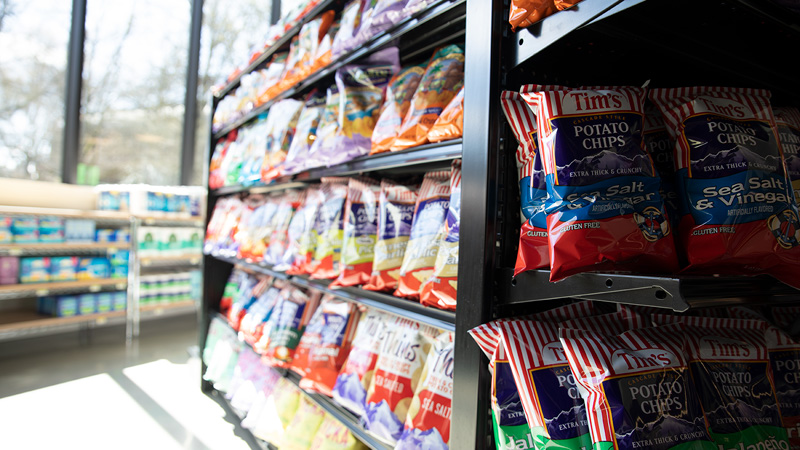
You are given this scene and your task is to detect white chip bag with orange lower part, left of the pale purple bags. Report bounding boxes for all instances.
[261,98,303,183]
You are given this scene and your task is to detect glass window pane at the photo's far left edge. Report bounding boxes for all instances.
[0,0,72,181]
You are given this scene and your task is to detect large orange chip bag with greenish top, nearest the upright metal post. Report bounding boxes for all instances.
[391,45,464,151]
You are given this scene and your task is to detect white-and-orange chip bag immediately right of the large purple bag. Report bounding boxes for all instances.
[370,65,425,154]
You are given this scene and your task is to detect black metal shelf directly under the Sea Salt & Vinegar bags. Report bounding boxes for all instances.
[499,269,800,312]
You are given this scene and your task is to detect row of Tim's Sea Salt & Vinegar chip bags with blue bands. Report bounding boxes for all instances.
[501,85,800,284]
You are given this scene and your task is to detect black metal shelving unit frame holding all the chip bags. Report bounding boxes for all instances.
[200,0,800,450]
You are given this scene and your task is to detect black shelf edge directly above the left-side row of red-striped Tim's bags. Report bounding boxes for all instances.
[211,139,462,196]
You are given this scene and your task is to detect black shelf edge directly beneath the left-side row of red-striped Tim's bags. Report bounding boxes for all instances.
[212,255,456,331]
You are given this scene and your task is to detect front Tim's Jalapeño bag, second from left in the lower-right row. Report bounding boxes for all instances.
[560,324,716,450]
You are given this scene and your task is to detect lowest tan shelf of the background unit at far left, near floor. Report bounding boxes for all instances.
[0,310,125,341]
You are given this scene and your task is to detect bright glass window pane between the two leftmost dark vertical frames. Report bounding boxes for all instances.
[81,0,191,185]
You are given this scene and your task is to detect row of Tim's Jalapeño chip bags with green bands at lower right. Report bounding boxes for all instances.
[470,303,798,449]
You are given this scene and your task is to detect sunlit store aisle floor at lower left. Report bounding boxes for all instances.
[0,316,249,450]
